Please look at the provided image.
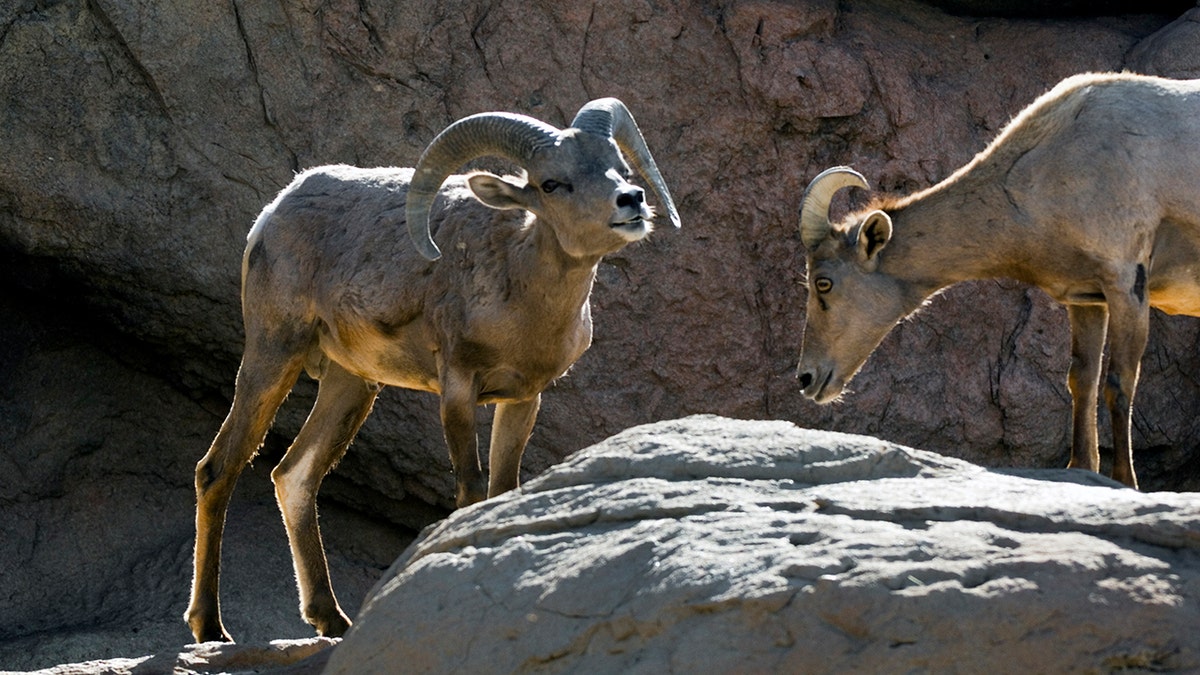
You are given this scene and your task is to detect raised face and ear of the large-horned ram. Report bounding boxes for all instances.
[469,130,654,257]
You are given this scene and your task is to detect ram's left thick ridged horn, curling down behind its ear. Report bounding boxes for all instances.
[404,113,559,261]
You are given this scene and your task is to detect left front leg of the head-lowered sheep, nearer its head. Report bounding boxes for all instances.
[1067,305,1109,471]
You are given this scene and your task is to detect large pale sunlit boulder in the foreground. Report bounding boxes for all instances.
[325,416,1200,674]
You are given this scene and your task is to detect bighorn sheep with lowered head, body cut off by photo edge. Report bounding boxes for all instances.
[797,74,1200,488]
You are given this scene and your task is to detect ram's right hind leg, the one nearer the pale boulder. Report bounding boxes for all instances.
[271,363,379,638]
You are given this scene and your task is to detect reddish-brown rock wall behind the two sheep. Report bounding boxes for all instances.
[0,0,1200,665]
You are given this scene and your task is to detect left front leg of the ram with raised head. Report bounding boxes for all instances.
[442,369,487,508]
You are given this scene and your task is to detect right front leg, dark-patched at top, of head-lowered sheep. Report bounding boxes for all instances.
[1104,270,1150,488]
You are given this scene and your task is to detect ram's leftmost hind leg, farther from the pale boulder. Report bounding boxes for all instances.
[184,339,302,643]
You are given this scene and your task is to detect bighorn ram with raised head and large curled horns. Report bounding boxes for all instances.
[185,98,679,641]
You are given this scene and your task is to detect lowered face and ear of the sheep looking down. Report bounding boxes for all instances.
[797,211,912,404]
